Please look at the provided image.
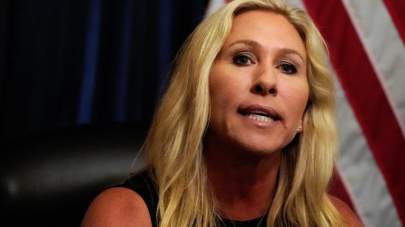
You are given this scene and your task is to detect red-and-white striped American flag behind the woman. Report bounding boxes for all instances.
[207,0,405,227]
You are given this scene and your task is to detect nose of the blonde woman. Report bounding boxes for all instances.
[251,68,277,96]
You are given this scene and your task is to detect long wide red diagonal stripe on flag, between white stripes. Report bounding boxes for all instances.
[304,0,405,223]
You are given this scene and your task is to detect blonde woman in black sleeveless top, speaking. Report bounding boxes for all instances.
[82,0,361,227]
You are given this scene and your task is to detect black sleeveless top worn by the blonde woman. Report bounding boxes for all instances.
[119,171,266,227]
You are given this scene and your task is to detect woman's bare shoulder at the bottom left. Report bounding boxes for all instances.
[81,187,152,227]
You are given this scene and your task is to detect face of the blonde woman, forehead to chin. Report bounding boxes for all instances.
[208,10,309,153]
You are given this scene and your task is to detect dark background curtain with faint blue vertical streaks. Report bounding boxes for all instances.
[0,0,207,138]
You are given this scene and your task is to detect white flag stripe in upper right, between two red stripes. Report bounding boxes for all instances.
[343,0,405,137]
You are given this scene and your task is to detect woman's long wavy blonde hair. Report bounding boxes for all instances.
[144,0,342,227]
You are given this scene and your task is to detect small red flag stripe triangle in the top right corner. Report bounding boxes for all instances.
[384,0,405,44]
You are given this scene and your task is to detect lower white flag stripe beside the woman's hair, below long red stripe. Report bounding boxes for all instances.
[336,78,401,227]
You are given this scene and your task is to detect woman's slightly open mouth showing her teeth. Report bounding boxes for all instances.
[238,105,281,123]
